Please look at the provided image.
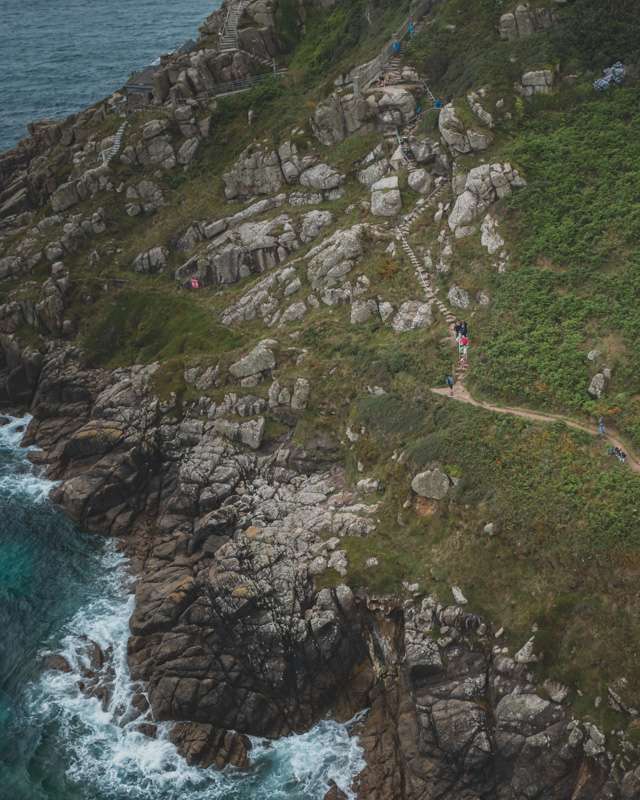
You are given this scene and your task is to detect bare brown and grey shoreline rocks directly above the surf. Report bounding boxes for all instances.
[0,346,637,800]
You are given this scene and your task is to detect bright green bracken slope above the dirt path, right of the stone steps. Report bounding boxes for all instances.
[473,88,640,445]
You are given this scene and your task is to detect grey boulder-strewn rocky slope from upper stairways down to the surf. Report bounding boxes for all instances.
[0,2,640,800]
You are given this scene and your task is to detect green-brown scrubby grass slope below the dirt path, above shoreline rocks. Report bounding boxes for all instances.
[321,388,640,727]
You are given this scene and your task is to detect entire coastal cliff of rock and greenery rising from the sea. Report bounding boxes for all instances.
[0,0,640,800]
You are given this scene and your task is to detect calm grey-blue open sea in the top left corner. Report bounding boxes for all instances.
[0,0,221,152]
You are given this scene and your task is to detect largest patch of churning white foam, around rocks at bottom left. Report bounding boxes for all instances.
[31,516,365,800]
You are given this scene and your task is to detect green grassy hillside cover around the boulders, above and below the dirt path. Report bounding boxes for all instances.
[1,0,640,756]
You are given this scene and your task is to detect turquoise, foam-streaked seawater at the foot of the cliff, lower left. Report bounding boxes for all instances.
[0,419,364,800]
